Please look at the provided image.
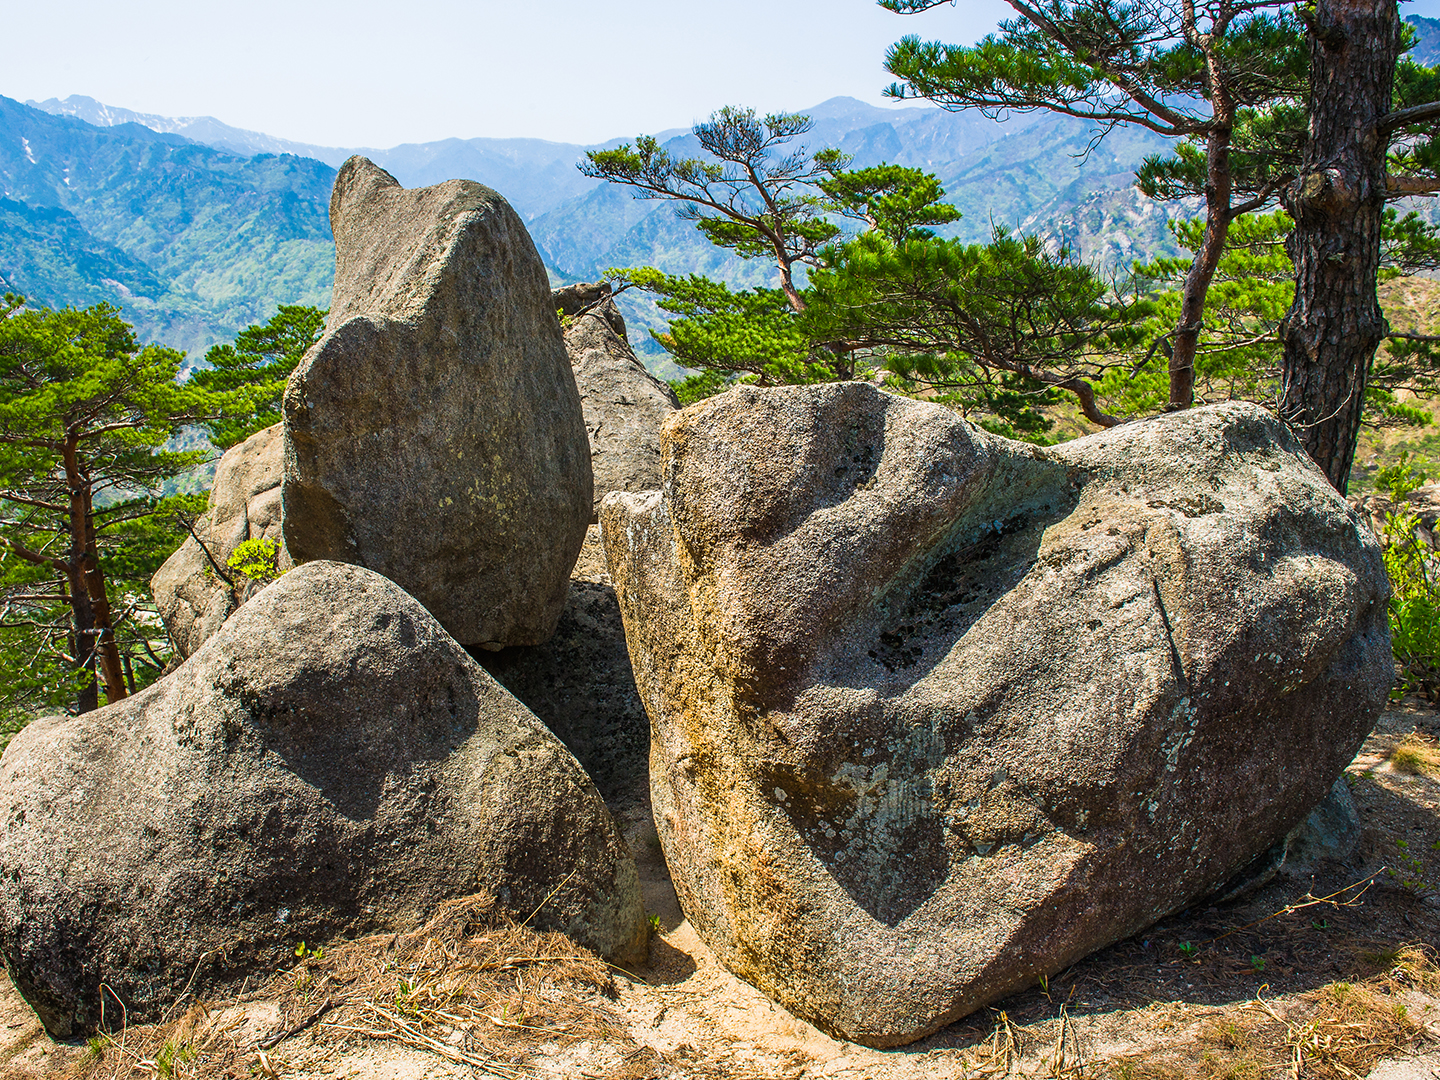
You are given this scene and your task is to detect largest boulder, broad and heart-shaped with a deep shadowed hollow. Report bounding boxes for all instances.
[600,383,1391,1047]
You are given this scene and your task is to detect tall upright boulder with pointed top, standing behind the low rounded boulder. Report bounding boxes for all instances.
[282,157,592,648]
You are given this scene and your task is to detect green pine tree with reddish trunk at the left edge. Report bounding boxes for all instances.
[0,297,228,733]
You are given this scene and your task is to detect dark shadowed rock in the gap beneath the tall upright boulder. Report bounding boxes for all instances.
[475,526,649,806]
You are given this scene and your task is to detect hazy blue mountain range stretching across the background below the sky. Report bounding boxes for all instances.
[0,16,1440,372]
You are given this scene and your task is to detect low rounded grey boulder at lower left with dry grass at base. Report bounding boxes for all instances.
[0,562,648,1038]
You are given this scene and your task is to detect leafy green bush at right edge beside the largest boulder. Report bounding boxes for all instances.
[1377,454,1440,701]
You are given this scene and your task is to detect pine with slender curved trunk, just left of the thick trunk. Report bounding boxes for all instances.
[880,0,1308,409]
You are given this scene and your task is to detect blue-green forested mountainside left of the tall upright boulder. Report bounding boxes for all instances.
[0,98,334,357]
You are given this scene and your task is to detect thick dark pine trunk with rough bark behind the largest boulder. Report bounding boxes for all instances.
[1280,0,1400,494]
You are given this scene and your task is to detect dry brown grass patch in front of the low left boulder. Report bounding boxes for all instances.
[78,896,639,1080]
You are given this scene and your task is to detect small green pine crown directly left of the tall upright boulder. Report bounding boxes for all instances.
[190,304,325,449]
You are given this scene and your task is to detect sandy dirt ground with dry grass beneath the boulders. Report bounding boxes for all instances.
[0,704,1440,1080]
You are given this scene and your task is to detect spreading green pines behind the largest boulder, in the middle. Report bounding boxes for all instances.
[582,108,1126,441]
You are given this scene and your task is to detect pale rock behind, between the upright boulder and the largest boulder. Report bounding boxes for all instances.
[554,285,680,520]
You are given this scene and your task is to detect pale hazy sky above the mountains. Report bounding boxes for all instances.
[8,0,1440,147]
